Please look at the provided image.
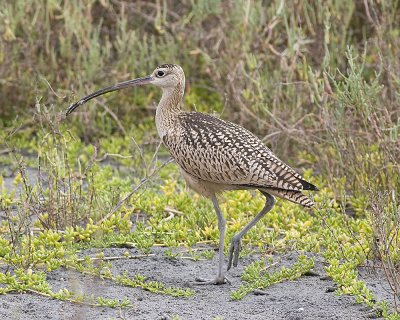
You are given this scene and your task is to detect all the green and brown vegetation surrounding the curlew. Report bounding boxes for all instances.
[0,0,400,319]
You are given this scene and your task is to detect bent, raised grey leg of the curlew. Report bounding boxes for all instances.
[227,191,276,270]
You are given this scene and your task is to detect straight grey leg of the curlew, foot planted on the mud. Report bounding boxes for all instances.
[196,195,229,284]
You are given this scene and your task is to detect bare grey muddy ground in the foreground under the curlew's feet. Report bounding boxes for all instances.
[0,248,388,320]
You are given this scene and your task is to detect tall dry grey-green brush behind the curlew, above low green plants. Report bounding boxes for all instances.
[0,0,400,189]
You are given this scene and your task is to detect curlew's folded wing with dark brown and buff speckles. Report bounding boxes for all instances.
[163,112,309,190]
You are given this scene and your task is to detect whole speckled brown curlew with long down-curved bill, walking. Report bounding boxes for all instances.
[66,64,318,285]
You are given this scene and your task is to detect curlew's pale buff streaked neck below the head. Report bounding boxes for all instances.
[156,85,184,139]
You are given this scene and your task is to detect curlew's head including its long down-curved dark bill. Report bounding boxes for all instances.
[66,64,185,115]
